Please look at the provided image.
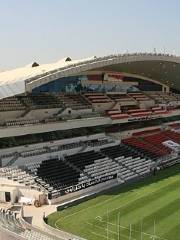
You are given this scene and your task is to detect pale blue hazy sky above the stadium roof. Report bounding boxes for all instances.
[0,0,180,70]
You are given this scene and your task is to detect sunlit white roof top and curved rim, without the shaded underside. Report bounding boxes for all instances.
[0,53,180,98]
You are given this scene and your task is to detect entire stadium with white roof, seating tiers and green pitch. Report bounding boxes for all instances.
[0,53,180,240]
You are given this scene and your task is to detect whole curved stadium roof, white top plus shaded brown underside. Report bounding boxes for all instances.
[0,53,180,98]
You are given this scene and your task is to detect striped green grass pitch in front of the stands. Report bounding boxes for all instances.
[47,165,180,240]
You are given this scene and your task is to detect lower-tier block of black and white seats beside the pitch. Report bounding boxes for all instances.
[24,144,153,199]
